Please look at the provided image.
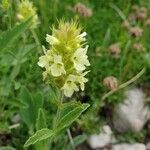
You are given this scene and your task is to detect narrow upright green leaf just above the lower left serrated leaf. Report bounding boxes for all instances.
[36,109,47,130]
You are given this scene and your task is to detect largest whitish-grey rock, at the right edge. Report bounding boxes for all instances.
[113,88,150,132]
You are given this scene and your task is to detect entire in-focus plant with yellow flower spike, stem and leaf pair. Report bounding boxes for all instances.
[25,20,90,149]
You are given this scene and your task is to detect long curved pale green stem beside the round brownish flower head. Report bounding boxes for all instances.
[102,68,146,100]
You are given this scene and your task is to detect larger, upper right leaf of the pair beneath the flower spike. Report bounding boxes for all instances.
[55,102,89,131]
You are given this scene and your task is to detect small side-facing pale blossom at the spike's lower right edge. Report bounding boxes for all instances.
[77,71,89,91]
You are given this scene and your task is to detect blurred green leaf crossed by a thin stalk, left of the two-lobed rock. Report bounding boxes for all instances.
[66,134,87,150]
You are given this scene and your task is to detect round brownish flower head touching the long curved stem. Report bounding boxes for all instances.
[103,76,118,90]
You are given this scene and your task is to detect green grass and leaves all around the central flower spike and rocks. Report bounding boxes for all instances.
[0,0,150,150]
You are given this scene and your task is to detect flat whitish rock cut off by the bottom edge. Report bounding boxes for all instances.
[112,143,146,150]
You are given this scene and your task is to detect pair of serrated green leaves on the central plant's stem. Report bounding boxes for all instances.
[24,102,89,147]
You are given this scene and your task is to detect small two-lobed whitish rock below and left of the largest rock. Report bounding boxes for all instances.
[88,125,116,149]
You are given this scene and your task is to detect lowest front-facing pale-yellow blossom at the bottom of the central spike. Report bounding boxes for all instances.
[62,75,79,97]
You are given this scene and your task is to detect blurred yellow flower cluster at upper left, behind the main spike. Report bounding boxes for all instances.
[17,0,39,28]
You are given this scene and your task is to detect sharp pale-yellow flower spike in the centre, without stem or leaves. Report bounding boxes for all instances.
[38,21,90,97]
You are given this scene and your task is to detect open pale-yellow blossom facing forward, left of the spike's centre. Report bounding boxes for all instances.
[50,55,66,77]
